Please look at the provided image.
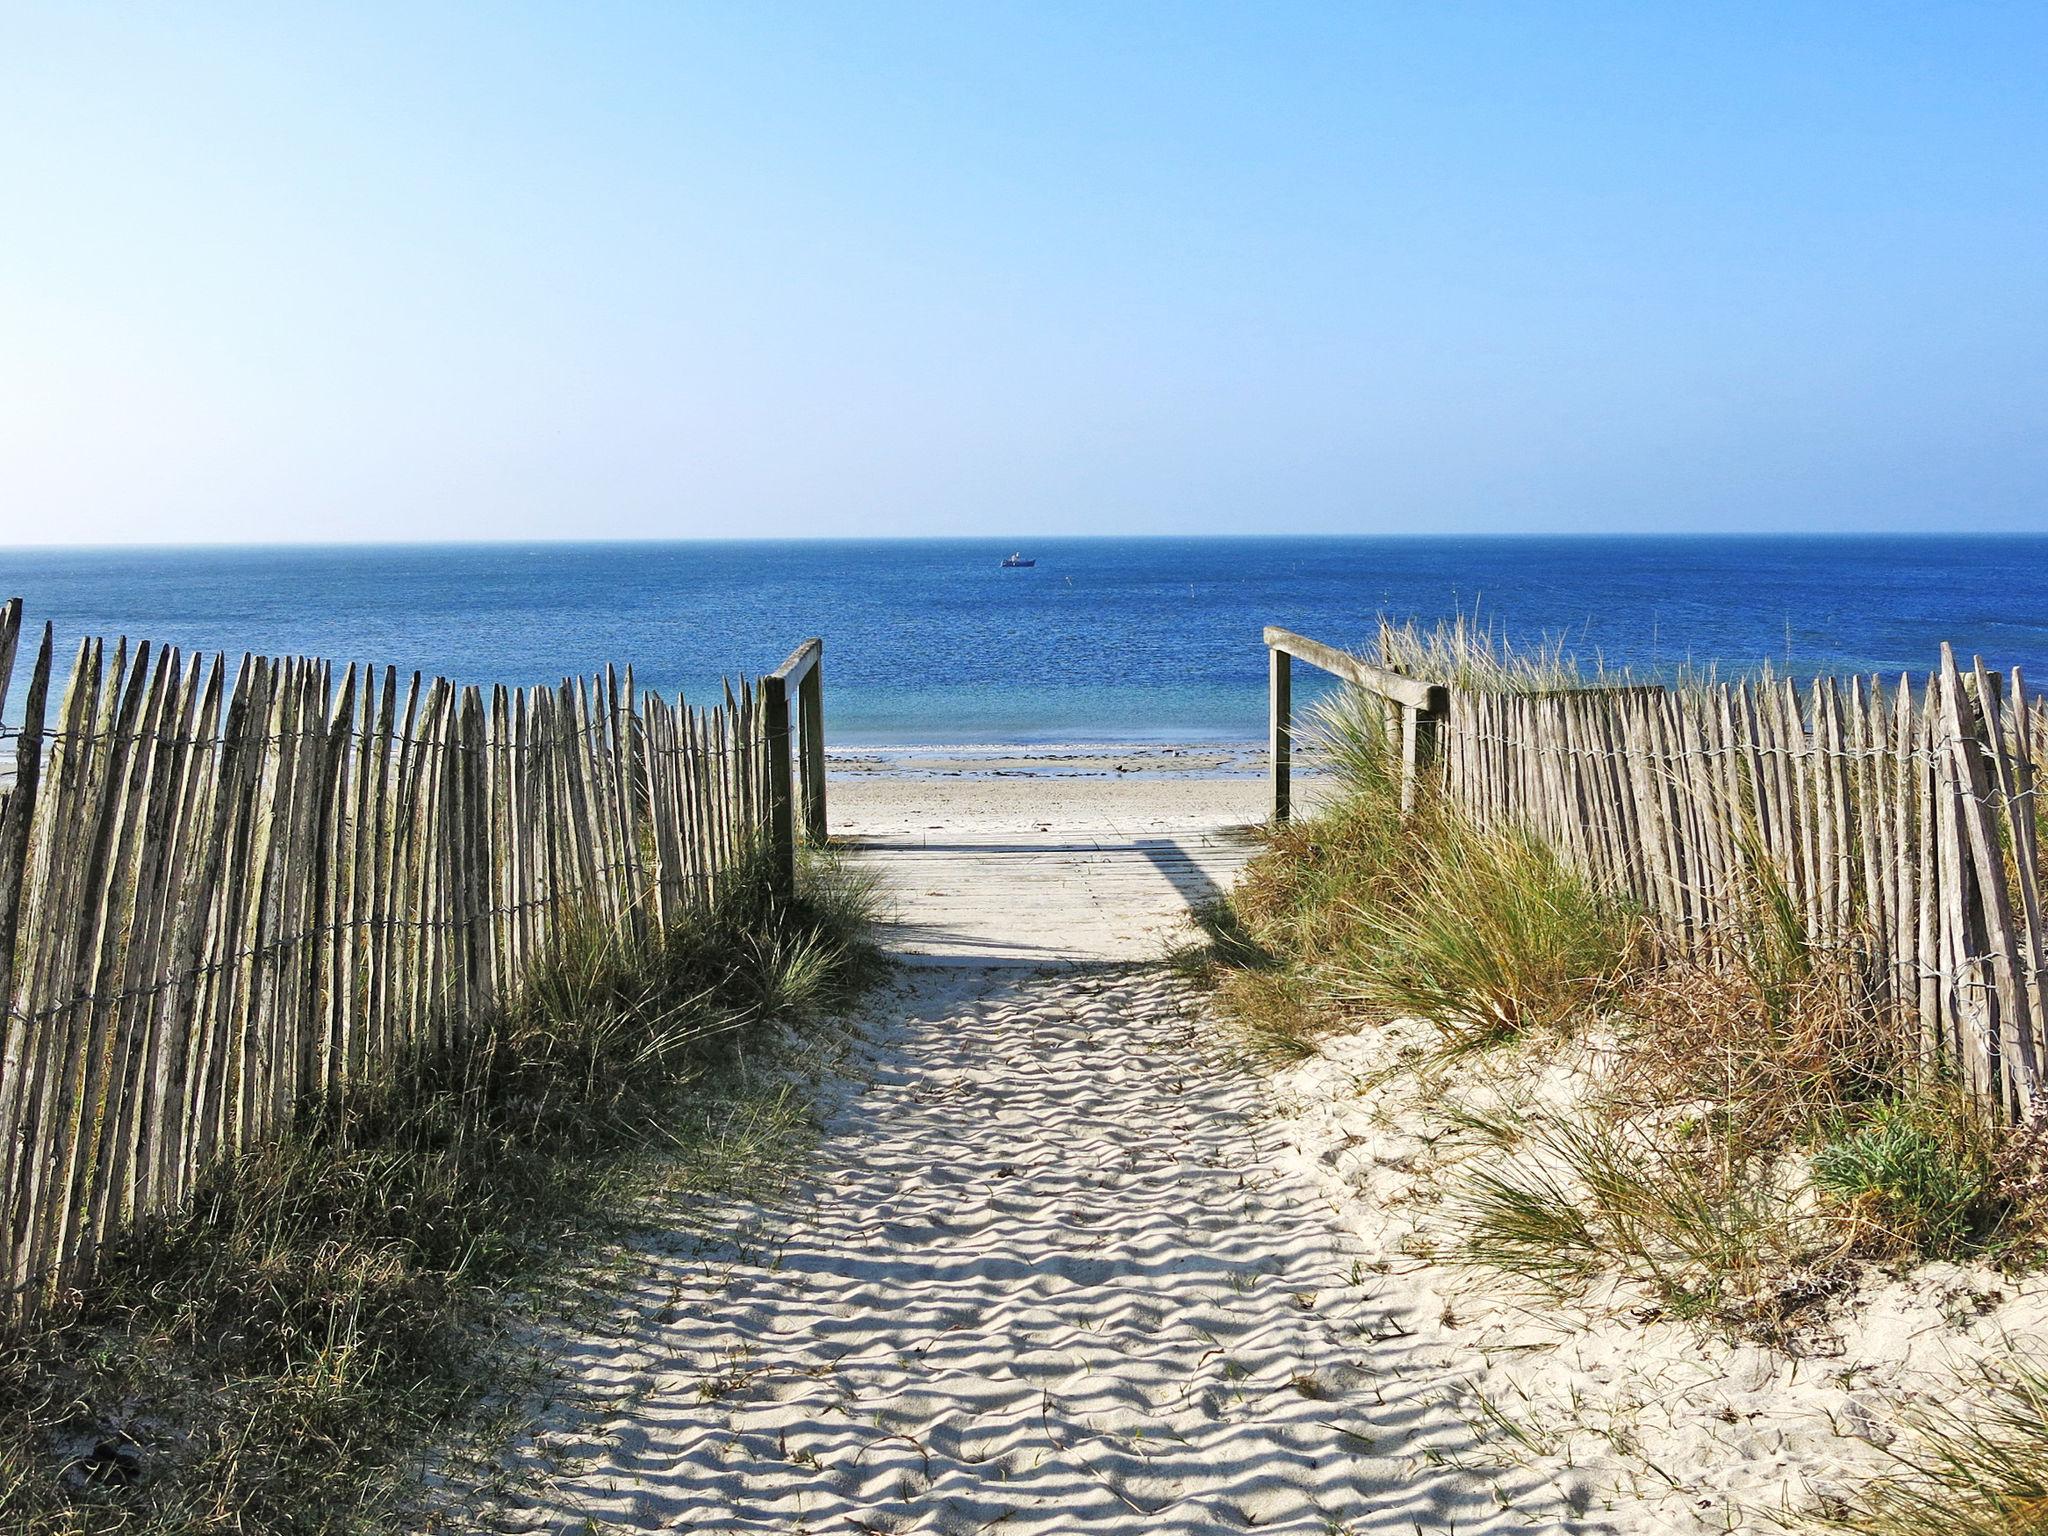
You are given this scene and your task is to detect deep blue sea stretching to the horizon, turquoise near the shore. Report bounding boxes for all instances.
[0,537,2048,743]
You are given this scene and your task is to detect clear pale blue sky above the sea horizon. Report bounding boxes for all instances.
[0,0,2048,543]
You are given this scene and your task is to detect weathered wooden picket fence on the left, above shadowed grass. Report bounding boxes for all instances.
[0,598,798,1317]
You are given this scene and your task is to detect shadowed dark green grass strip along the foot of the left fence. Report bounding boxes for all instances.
[0,860,879,1536]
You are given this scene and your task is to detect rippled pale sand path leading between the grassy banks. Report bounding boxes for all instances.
[456,969,1583,1536]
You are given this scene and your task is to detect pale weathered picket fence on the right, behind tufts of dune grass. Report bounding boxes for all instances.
[1440,645,2048,1116]
